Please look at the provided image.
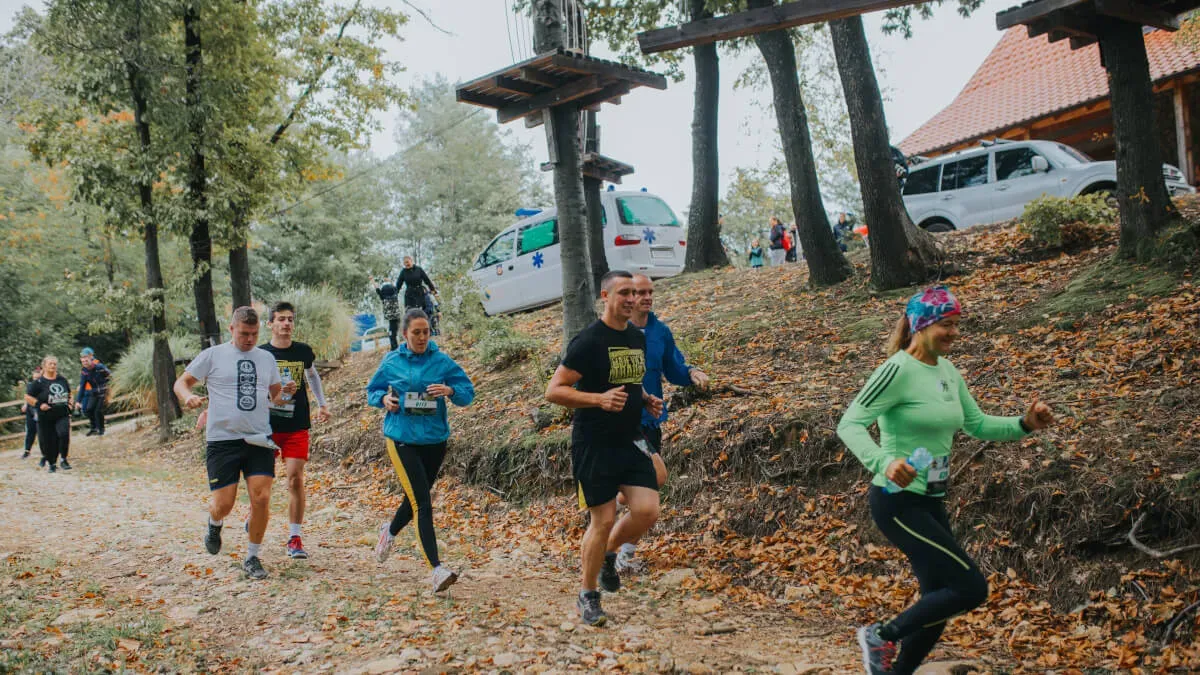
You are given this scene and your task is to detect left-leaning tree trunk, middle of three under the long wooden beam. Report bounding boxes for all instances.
[749,0,854,286]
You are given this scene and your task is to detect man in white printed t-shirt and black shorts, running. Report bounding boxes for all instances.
[175,307,296,579]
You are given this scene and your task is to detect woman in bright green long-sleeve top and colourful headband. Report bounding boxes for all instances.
[838,286,1054,675]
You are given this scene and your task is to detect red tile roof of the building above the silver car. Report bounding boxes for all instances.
[900,26,1200,155]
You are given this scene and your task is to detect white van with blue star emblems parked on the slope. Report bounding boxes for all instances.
[470,189,688,315]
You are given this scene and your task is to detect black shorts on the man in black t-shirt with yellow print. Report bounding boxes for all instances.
[571,441,659,509]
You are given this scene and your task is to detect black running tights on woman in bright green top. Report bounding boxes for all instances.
[870,486,988,675]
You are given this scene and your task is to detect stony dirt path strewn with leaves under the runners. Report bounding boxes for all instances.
[0,434,883,673]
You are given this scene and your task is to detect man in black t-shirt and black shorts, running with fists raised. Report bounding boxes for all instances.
[546,270,662,626]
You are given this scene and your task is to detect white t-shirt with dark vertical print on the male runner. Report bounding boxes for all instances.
[187,342,281,442]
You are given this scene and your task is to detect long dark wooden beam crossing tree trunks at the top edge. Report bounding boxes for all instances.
[637,0,926,54]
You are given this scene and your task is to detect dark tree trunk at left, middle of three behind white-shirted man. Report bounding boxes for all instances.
[184,2,221,350]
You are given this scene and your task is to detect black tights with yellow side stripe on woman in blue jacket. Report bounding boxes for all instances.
[388,438,446,568]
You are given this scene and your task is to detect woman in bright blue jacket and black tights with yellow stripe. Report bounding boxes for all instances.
[367,309,475,592]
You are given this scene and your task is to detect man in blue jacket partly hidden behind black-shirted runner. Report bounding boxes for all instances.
[617,274,708,572]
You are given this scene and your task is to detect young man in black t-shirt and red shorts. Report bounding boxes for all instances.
[258,303,329,560]
